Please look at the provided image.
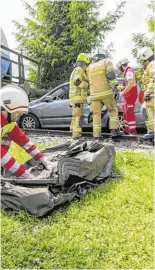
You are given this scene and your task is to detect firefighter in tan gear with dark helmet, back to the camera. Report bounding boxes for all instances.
[88,51,120,137]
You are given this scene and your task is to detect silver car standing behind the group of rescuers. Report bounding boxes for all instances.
[19,79,145,130]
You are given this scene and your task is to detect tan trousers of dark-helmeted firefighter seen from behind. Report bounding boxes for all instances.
[90,94,118,137]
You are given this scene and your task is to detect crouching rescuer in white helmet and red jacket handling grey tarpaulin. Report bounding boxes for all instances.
[0,85,51,179]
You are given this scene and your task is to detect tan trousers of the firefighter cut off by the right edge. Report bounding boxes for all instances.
[142,97,155,132]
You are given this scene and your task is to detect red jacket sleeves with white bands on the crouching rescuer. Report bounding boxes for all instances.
[1,112,44,176]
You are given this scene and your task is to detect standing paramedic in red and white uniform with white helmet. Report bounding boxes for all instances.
[117,58,138,135]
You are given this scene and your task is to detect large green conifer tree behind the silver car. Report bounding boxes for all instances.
[14,0,125,88]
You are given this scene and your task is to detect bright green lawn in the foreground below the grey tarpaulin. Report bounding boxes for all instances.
[1,147,154,269]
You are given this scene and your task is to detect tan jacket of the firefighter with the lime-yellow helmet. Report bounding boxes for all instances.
[69,67,89,104]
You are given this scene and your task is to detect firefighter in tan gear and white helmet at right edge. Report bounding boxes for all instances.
[138,47,155,139]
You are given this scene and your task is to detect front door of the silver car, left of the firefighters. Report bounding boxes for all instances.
[42,84,72,127]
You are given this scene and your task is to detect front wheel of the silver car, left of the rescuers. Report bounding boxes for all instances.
[20,114,40,129]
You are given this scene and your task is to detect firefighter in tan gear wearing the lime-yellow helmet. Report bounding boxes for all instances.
[69,53,90,139]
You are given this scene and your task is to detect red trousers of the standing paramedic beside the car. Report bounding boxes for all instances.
[123,97,137,134]
